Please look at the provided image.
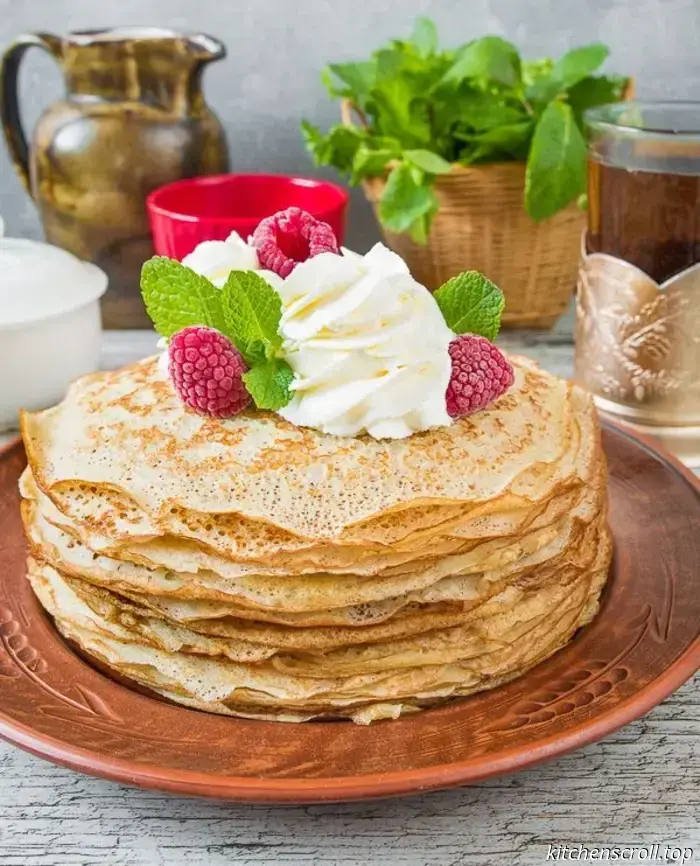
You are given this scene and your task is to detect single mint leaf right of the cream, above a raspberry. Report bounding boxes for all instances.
[433,271,505,340]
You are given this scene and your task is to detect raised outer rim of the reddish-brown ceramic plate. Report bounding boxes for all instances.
[0,419,700,805]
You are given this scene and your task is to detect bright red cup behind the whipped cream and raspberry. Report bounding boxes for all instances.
[146,174,349,259]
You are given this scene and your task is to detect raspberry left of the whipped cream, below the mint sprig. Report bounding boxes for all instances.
[168,325,250,418]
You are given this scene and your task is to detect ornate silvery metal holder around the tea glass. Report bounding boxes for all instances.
[576,236,700,465]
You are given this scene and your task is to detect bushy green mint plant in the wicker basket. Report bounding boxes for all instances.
[302,18,628,236]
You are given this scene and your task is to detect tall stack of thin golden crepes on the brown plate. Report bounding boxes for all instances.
[15,359,611,724]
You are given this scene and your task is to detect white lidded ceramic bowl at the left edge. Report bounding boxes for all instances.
[0,221,107,430]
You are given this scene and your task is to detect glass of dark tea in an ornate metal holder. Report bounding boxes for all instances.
[575,102,700,464]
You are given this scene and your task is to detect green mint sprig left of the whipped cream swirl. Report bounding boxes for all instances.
[141,256,294,409]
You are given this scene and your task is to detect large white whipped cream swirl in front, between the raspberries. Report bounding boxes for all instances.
[276,244,454,439]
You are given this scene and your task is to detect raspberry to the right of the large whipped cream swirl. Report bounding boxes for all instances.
[445,334,514,418]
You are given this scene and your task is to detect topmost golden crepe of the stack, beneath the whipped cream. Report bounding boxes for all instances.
[22,359,595,532]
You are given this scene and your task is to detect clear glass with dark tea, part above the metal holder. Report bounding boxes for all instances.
[587,103,700,282]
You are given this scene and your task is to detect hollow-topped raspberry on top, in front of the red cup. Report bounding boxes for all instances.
[252,207,338,278]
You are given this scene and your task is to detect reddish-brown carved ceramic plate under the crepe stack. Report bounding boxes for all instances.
[0,426,700,803]
